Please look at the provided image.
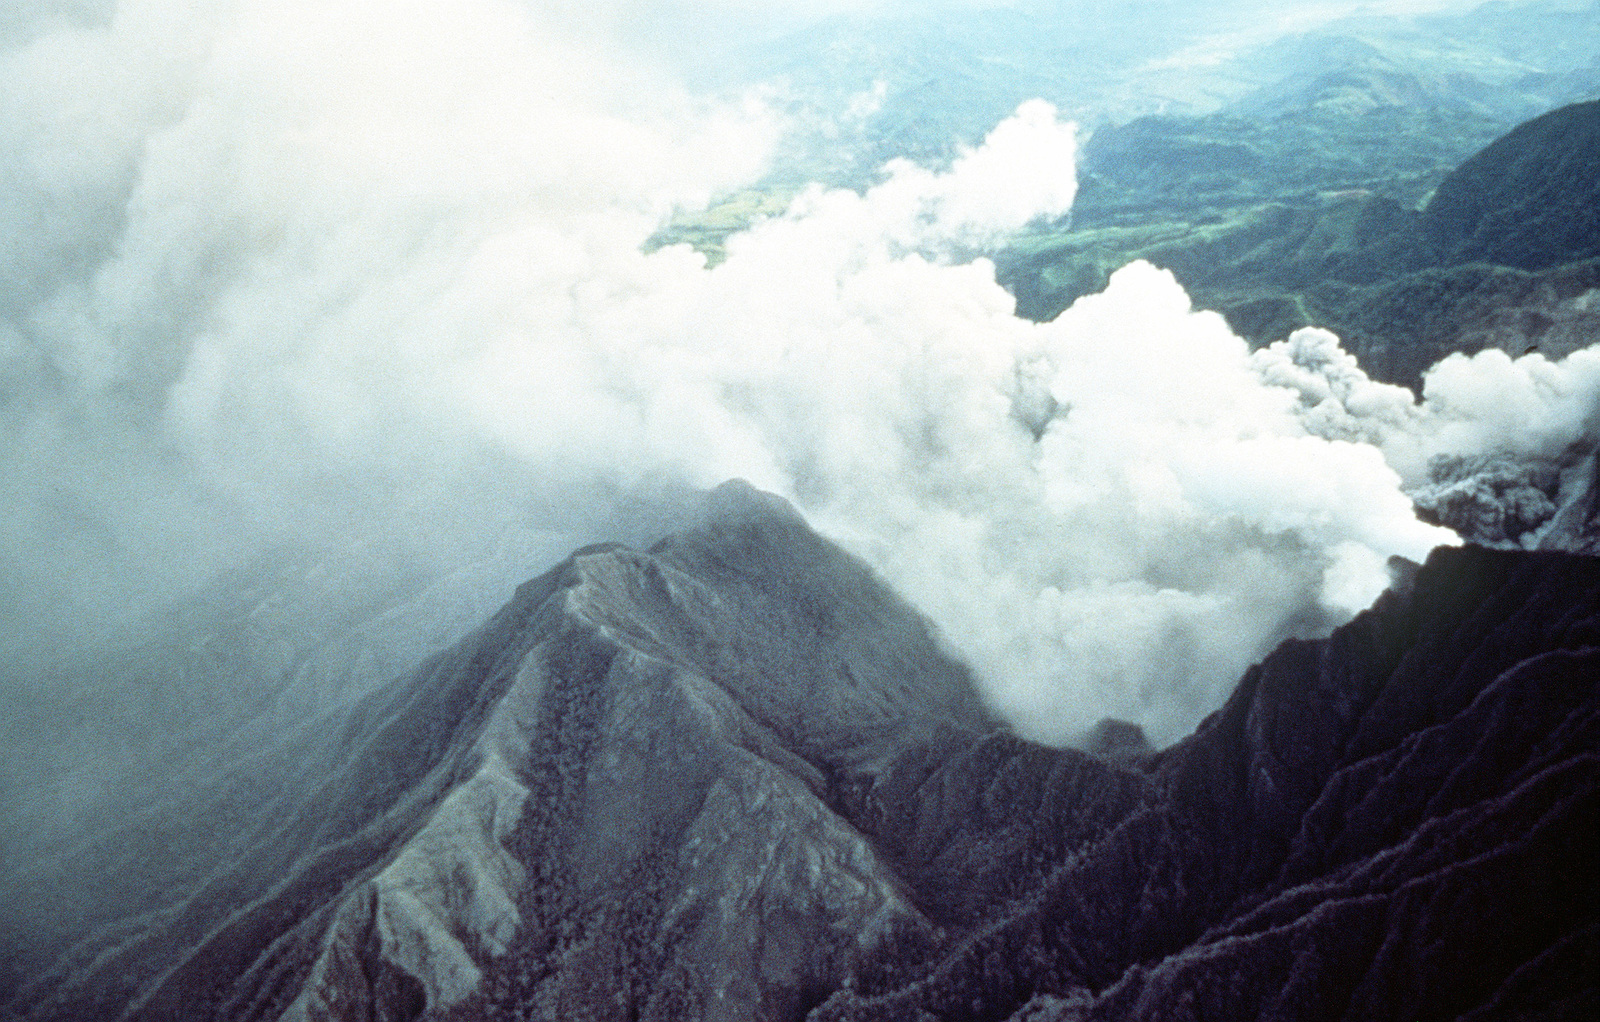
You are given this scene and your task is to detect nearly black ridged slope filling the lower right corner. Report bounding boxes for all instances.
[819,549,1600,1020]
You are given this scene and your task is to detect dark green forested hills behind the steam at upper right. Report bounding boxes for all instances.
[997,102,1600,387]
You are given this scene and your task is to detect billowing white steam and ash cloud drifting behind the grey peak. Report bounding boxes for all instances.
[0,0,1600,751]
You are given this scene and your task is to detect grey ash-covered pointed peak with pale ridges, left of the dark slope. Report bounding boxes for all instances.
[6,486,994,1019]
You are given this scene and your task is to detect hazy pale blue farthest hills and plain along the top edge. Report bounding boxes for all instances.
[696,0,1600,184]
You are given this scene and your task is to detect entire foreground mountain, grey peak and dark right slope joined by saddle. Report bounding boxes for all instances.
[5,485,1600,1020]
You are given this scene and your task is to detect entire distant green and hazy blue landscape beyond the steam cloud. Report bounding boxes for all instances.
[653,2,1600,396]
